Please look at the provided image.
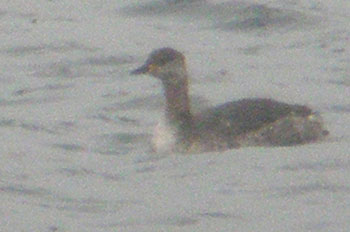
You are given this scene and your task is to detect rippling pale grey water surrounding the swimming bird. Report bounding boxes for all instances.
[0,0,350,232]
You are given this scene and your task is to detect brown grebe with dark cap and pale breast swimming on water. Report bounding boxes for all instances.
[131,47,329,153]
